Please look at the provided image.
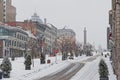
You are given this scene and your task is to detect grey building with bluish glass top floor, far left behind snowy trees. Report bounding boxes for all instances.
[0,25,28,57]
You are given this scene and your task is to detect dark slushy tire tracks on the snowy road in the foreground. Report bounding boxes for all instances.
[36,62,84,80]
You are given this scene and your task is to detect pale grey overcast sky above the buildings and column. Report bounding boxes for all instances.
[12,0,111,48]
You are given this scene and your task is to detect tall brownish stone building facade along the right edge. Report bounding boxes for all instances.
[109,0,120,80]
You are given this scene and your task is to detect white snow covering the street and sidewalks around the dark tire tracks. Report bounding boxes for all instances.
[1,52,116,80]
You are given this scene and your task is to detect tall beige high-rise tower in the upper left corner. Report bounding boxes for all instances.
[0,0,16,22]
